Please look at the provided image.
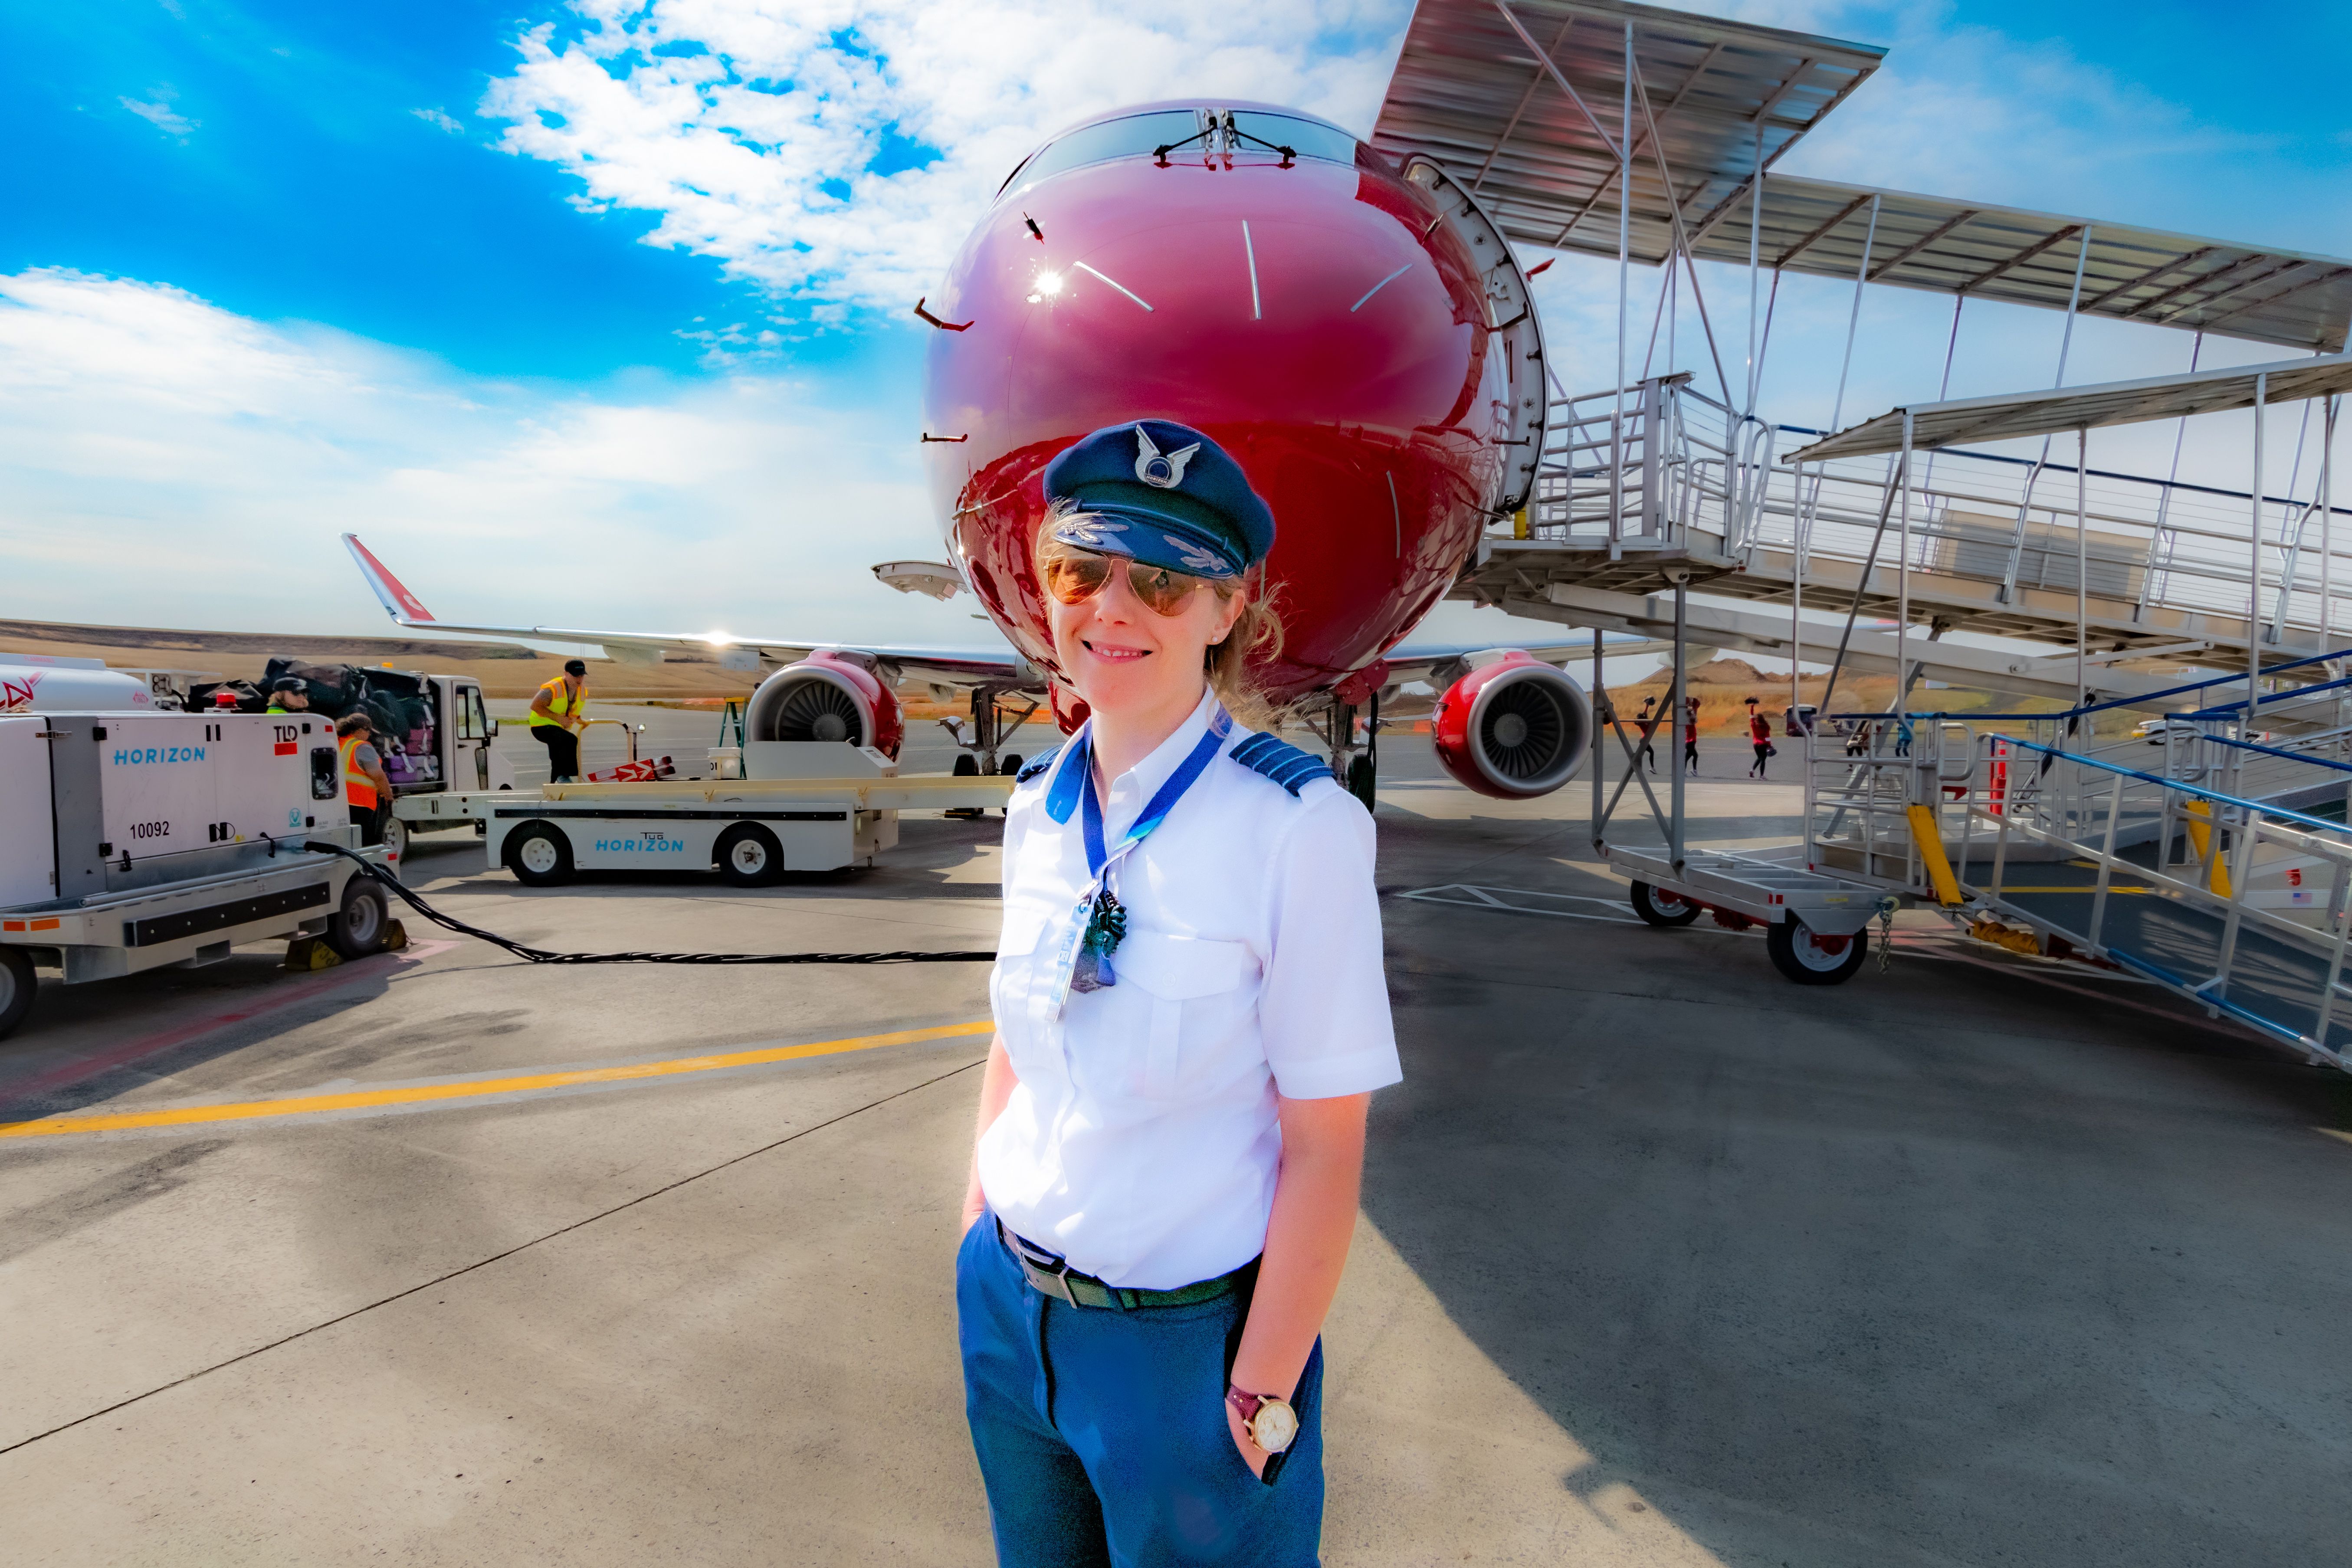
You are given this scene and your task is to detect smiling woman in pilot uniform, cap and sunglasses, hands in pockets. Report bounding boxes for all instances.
[957,418,1399,1566]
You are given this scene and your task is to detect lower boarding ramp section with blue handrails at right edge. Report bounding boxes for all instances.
[1804,656,2352,1069]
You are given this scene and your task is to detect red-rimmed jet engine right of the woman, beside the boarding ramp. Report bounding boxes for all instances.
[1430,649,1592,799]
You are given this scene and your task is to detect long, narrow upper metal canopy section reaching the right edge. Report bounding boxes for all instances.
[1693,174,2352,353]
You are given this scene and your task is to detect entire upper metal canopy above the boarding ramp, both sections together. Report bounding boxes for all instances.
[1371,0,2352,353]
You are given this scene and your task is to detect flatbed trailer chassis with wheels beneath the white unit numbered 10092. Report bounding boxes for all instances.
[0,825,390,1039]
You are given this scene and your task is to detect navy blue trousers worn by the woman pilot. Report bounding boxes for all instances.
[955,1215,1324,1568]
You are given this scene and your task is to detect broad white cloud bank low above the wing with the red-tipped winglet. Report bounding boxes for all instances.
[0,270,993,646]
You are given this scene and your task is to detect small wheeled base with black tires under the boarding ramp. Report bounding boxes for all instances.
[1609,844,1900,985]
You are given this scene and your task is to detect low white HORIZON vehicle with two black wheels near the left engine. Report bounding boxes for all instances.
[487,774,1014,886]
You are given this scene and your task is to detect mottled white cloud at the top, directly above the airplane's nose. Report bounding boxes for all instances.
[480,0,1409,322]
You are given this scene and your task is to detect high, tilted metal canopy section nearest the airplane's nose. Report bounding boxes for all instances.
[1371,0,1886,263]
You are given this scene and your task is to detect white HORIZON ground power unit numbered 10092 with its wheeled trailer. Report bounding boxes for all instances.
[0,705,388,1037]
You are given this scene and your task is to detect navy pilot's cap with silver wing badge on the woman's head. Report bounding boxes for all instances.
[1044,418,1275,578]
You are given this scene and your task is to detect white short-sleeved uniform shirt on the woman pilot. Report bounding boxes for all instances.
[978,696,1402,1291]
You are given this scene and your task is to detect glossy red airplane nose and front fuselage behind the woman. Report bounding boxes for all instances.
[924,113,1508,698]
